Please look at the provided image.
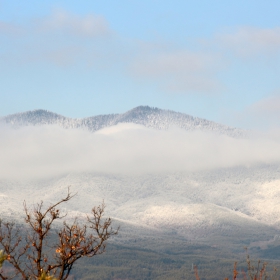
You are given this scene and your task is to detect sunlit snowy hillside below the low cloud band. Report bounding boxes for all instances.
[0,166,280,245]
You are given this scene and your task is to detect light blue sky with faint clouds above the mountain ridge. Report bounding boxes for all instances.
[0,0,280,128]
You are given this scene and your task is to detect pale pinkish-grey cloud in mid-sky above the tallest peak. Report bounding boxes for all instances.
[131,50,222,93]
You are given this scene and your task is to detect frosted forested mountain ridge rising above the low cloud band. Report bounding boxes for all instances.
[1,106,246,137]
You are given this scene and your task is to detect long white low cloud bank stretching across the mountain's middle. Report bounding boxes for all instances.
[0,124,280,179]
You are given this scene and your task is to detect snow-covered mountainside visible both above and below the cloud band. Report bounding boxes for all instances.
[0,106,280,242]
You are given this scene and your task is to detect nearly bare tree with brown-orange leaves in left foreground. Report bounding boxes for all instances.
[0,189,118,280]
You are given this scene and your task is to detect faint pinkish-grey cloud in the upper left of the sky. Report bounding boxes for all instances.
[0,10,114,67]
